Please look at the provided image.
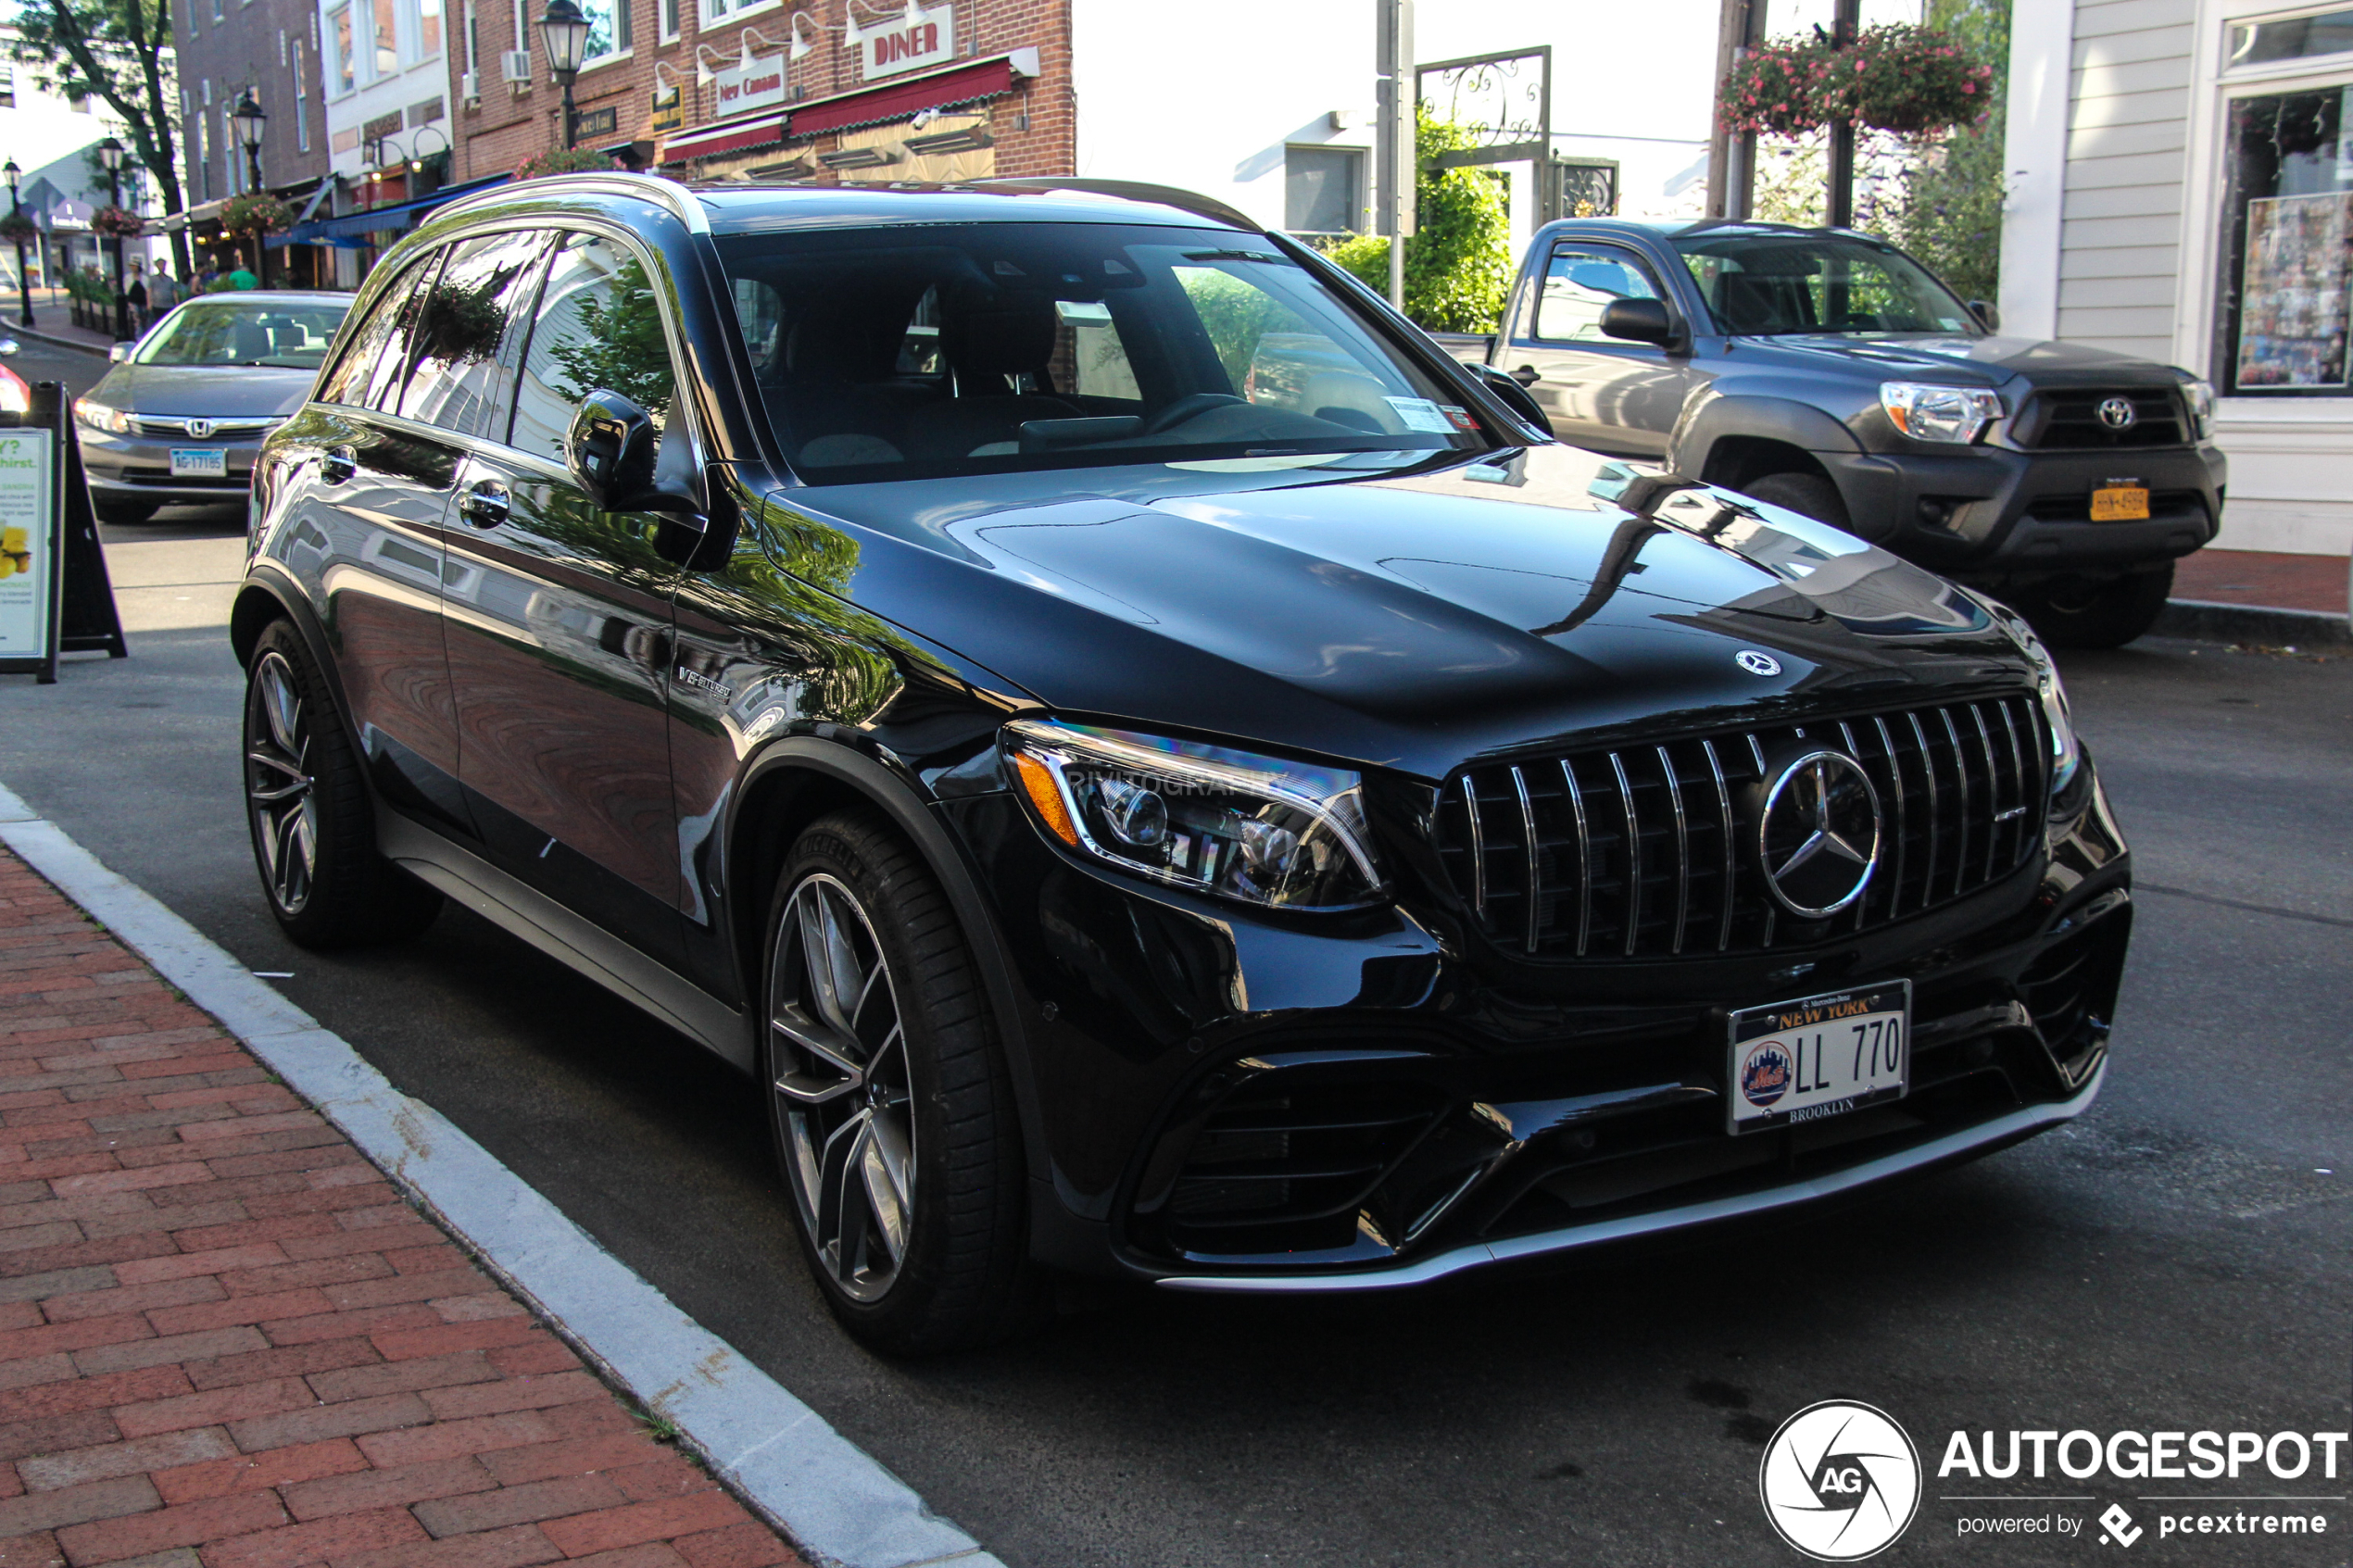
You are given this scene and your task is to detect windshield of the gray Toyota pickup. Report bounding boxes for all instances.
[1675,231,1983,339]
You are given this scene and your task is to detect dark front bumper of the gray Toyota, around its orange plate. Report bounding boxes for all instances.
[1817,445,2231,581]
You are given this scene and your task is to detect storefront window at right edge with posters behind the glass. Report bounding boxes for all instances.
[2214,87,2353,397]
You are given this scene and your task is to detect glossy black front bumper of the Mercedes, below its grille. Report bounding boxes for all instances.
[950,757,2132,1293]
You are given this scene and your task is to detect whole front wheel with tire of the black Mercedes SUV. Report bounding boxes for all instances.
[760,811,1042,1357]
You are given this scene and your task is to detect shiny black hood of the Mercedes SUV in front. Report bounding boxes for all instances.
[772,446,2023,778]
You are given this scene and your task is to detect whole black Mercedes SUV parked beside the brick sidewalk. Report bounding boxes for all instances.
[233,174,2132,1351]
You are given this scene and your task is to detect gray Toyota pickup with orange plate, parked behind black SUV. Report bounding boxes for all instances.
[1487,219,2226,646]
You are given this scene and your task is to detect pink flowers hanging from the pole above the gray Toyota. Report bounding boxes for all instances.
[1720,23,1993,136]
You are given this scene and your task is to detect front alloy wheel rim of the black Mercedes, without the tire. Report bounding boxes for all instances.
[767,872,915,1302]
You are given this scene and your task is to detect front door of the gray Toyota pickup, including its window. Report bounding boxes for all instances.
[1499,240,1690,456]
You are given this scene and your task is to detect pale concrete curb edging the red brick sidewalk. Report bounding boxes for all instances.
[0,785,1005,1568]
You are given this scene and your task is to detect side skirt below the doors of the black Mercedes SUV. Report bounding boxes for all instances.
[376,804,753,1072]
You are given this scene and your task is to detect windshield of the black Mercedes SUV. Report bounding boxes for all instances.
[718,223,1491,484]
